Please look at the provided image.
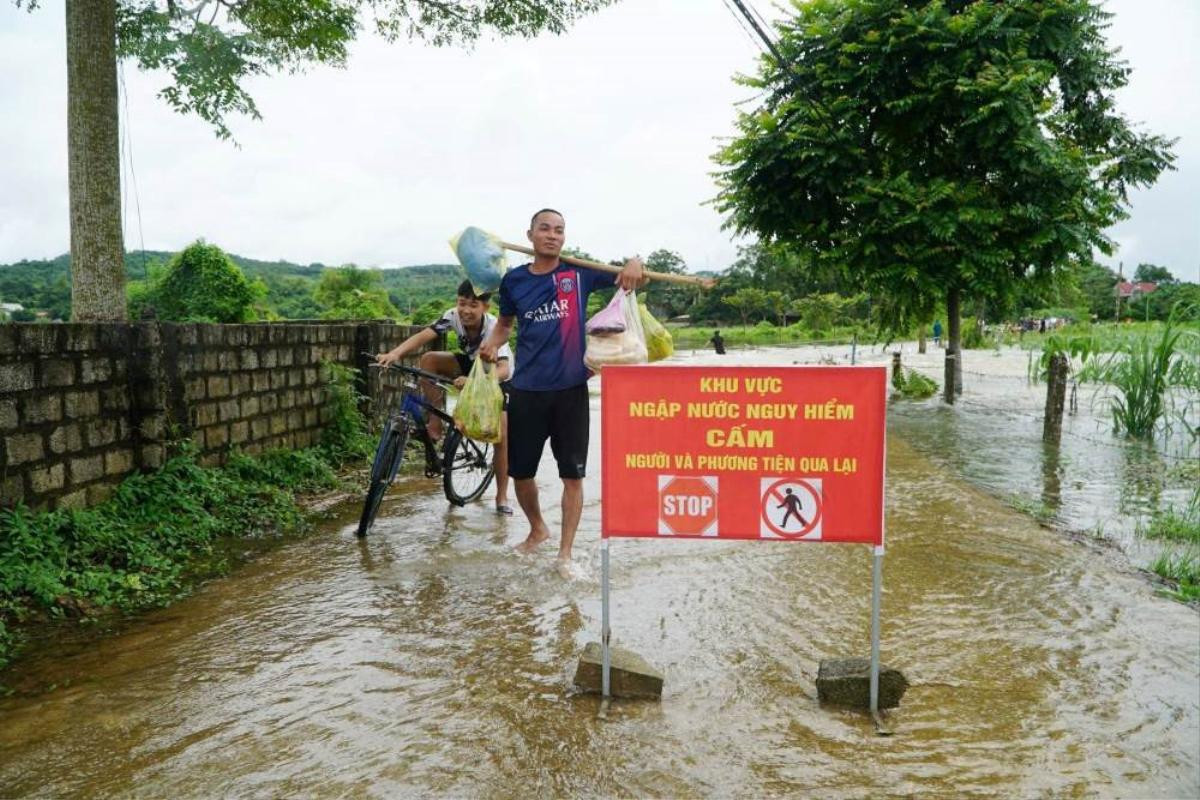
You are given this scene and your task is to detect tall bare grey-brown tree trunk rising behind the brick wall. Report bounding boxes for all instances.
[66,0,126,320]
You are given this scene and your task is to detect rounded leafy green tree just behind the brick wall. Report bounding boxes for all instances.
[145,241,266,323]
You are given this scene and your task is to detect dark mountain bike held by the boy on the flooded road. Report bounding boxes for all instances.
[358,365,494,536]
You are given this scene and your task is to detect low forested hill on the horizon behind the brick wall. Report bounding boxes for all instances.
[0,251,466,319]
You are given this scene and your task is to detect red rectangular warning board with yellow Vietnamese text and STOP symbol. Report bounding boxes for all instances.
[600,365,888,545]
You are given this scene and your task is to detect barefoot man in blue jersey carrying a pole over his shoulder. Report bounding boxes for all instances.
[479,209,646,577]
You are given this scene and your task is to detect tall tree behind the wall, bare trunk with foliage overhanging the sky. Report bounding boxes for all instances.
[16,0,614,319]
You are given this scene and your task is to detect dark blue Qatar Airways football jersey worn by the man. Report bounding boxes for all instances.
[499,263,616,391]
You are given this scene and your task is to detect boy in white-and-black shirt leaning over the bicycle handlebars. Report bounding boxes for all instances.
[376,281,512,515]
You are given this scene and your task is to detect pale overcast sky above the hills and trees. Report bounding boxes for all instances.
[0,0,1200,281]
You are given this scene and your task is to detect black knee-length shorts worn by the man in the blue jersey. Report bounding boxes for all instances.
[509,384,589,480]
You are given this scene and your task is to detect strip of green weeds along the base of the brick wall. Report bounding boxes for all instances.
[0,368,371,667]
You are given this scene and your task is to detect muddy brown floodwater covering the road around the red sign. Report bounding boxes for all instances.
[0,351,1200,798]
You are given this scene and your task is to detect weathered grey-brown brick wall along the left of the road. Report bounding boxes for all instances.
[0,323,429,507]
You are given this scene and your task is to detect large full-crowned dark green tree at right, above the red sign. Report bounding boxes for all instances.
[715,0,1174,391]
